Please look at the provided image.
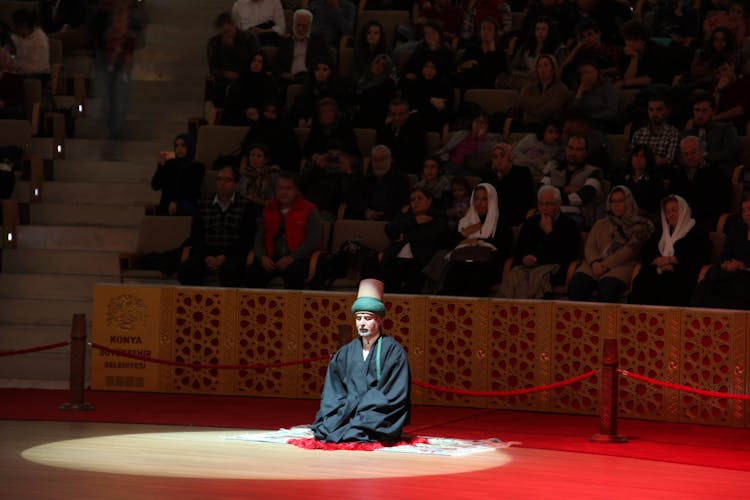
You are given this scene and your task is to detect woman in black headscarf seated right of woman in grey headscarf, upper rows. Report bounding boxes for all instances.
[402,56,453,132]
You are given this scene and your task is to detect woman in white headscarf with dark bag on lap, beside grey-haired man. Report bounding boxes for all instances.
[443,182,513,297]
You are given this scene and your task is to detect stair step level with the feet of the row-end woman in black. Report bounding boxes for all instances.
[31,202,144,227]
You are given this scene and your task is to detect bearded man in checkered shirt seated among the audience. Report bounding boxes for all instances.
[632,94,680,170]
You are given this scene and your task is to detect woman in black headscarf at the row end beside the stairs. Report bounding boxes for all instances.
[151,134,206,215]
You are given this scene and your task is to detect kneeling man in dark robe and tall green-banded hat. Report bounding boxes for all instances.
[312,279,411,443]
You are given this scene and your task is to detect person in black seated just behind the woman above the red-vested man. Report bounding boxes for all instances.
[241,101,301,172]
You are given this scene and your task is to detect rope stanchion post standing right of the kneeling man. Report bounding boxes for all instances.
[591,338,628,443]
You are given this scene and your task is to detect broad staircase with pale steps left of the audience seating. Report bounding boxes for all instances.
[0,0,225,387]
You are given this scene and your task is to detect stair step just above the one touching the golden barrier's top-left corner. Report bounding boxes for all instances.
[3,248,120,276]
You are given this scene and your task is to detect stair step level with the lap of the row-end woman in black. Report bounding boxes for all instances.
[15,181,159,206]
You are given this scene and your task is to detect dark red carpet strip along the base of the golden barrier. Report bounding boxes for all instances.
[0,389,750,471]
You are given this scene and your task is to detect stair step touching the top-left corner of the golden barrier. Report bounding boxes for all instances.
[0,273,120,300]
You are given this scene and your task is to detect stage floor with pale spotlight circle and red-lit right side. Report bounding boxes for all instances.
[0,420,750,500]
